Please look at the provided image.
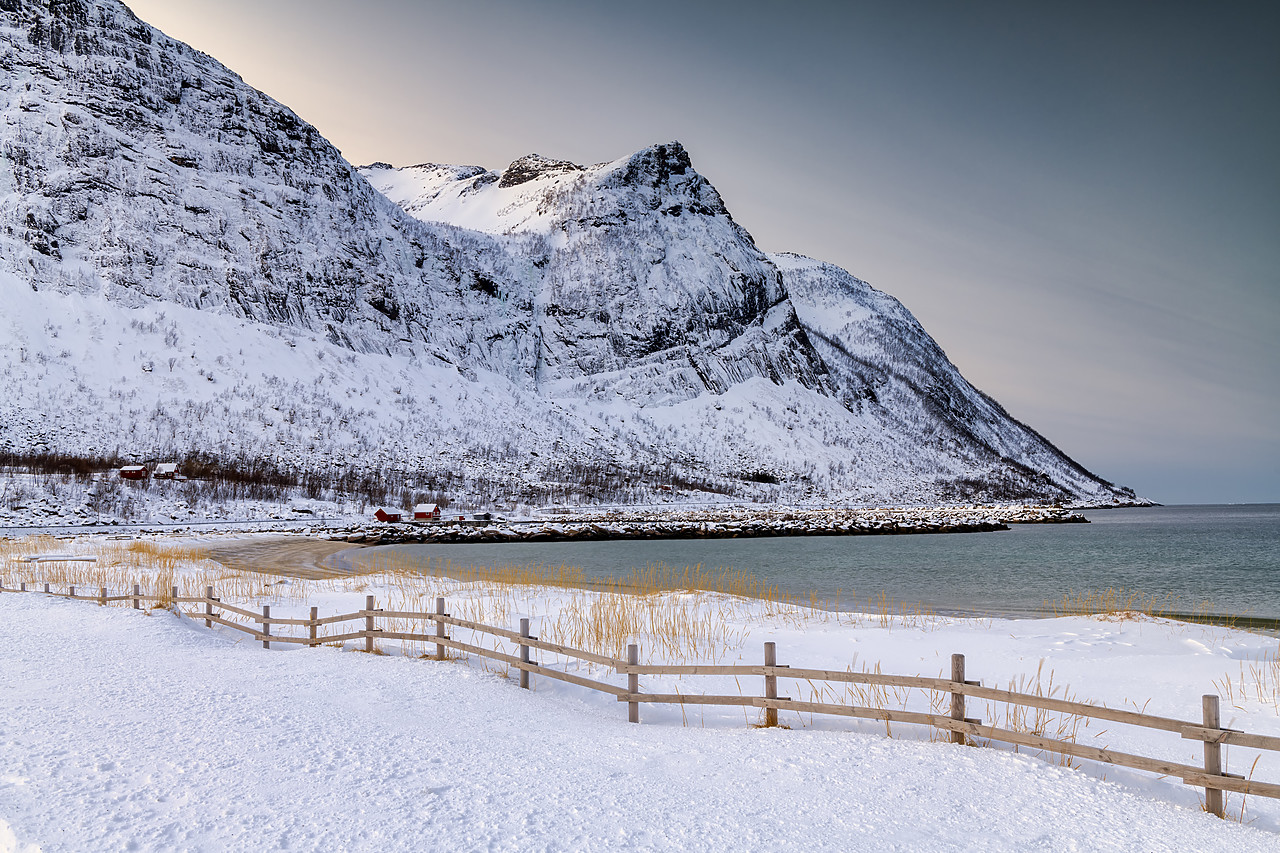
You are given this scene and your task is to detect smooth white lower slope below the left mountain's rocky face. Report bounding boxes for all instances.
[0,266,691,503]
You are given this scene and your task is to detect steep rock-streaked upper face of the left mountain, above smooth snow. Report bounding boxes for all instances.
[0,0,531,375]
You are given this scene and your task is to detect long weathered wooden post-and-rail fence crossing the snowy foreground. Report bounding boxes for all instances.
[0,583,1280,817]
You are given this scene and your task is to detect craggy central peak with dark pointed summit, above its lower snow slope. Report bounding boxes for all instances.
[365,142,823,402]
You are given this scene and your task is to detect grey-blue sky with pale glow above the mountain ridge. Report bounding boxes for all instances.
[127,0,1280,503]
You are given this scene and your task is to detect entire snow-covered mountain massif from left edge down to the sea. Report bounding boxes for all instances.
[0,0,1133,502]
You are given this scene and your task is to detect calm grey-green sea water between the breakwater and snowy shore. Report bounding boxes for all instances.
[381,503,1280,619]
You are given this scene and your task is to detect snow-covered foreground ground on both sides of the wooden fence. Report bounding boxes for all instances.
[0,545,1280,850]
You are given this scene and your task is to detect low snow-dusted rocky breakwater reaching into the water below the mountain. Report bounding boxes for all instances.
[330,506,1087,544]
